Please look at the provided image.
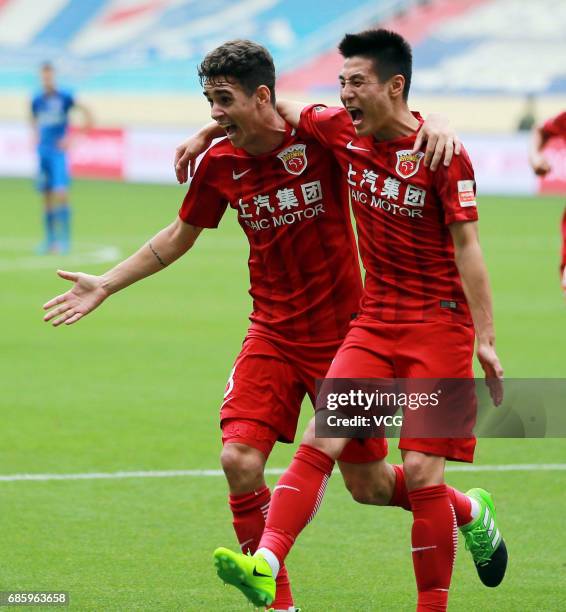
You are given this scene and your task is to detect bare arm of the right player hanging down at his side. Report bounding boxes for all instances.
[450,221,503,406]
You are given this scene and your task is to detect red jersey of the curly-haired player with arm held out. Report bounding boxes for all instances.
[179,126,362,341]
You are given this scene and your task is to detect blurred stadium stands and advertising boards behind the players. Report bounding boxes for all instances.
[0,0,566,186]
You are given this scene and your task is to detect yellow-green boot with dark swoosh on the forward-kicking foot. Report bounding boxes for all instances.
[212,548,275,608]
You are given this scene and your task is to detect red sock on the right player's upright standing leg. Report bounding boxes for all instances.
[409,484,458,612]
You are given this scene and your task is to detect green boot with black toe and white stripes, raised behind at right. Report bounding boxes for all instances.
[460,489,508,587]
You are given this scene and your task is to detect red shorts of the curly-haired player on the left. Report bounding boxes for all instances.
[220,327,385,463]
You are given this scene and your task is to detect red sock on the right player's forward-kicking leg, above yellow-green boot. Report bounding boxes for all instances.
[258,444,334,563]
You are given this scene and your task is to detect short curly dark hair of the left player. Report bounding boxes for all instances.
[198,40,275,106]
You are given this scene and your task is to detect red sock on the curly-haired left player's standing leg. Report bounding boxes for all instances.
[229,487,293,610]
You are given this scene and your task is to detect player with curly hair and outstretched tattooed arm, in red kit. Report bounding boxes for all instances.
[45,41,462,610]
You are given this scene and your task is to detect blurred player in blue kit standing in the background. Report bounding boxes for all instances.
[31,62,92,255]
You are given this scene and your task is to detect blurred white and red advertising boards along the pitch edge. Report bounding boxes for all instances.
[0,123,566,195]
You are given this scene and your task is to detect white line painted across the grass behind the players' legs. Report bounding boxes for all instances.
[0,463,566,482]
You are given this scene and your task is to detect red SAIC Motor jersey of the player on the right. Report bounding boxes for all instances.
[300,106,478,324]
